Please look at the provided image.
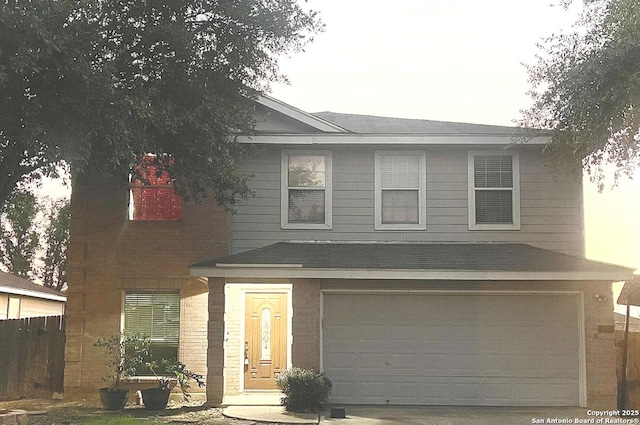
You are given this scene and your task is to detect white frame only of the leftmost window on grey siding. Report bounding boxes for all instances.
[280,150,333,230]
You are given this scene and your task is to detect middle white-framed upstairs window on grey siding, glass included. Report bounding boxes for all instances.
[375,151,426,230]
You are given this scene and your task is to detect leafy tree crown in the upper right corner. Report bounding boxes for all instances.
[521,0,640,188]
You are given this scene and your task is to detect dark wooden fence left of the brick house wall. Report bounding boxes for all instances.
[0,316,65,398]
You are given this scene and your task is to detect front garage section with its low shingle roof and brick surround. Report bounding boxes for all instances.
[192,242,633,410]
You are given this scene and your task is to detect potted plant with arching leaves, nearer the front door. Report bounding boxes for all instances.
[140,359,204,410]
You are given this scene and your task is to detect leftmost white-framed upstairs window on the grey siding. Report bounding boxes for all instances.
[281,151,331,229]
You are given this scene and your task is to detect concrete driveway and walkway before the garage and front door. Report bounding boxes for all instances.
[224,406,601,425]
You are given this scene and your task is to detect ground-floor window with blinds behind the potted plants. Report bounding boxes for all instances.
[124,291,180,375]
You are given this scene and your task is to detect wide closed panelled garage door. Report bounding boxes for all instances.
[322,293,581,406]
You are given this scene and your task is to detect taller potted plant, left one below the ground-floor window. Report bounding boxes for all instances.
[93,334,149,410]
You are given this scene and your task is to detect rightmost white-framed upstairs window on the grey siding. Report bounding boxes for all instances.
[468,152,520,230]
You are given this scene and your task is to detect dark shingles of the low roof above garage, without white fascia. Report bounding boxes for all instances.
[191,242,631,275]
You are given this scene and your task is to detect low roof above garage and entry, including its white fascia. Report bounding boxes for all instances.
[191,242,633,280]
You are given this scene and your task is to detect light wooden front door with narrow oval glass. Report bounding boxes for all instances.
[244,293,287,390]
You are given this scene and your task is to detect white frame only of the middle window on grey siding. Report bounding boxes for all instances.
[375,150,427,230]
